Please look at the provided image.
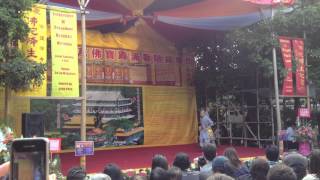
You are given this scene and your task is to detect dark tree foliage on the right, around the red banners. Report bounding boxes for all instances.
[192,0,320,105]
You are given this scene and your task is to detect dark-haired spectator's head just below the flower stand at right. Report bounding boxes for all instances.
[283,153,308,180]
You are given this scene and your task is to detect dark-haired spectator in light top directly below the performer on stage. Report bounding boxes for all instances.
[200,143,217,173]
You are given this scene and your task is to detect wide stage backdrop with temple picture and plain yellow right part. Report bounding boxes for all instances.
[30,85,197,149]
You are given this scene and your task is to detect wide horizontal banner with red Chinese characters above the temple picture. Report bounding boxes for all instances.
[78,47,195,86]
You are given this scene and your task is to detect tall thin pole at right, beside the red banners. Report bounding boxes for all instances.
[271,7,282,149]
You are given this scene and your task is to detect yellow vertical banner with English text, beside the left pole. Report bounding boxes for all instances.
[50,8,79,97]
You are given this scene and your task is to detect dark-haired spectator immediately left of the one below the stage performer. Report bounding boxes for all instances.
[173,153,199,180]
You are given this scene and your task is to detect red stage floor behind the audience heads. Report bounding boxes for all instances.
[60,144,264,175]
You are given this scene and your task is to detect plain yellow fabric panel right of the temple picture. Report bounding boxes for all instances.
[143,86,198,146]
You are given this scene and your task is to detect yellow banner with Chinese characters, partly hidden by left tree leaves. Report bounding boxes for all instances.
[17,4,47,96]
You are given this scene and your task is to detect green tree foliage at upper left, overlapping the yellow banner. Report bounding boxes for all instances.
[0,0,46,90]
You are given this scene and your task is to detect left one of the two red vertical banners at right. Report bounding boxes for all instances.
[279,37,293,96]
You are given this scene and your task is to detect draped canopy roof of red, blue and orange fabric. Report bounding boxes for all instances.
[48,0,292,42]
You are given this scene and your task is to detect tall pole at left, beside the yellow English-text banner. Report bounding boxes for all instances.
[78,0,89,169]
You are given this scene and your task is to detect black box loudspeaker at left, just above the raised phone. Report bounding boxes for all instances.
[22,113,44,137]
